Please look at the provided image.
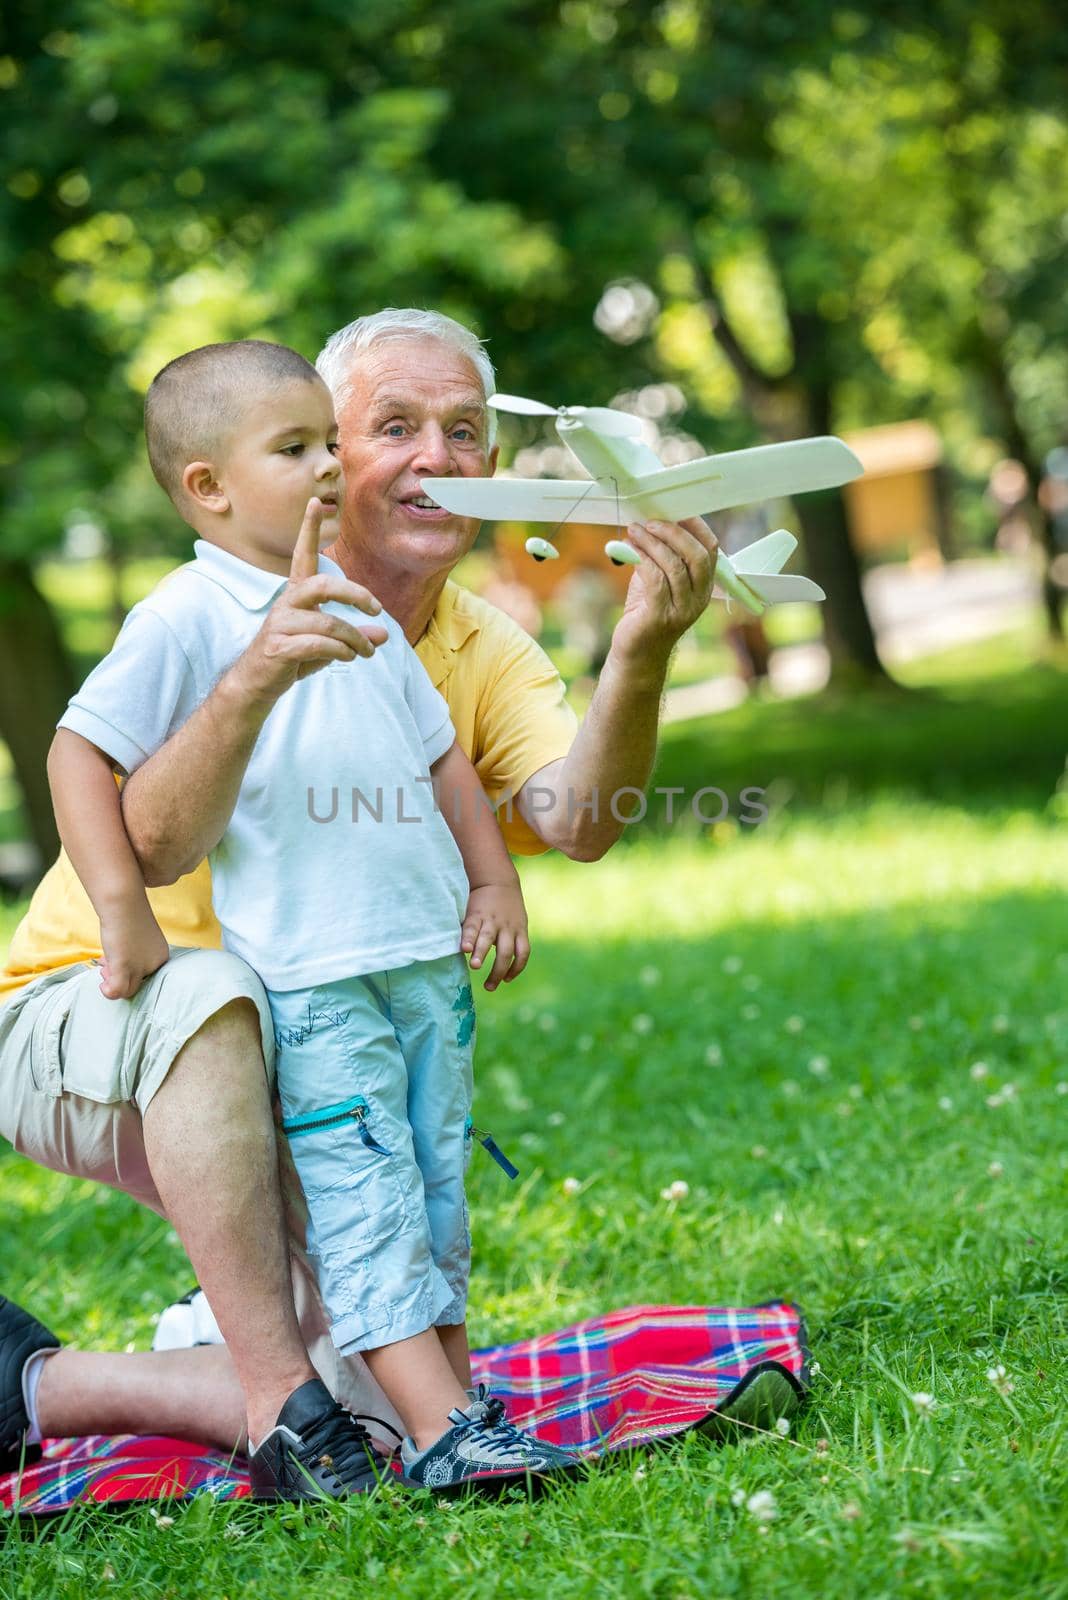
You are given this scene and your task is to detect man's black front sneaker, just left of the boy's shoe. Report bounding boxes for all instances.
[248,1378,393,1501]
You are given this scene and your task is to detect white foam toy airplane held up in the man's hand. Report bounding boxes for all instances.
[420,394,863,616]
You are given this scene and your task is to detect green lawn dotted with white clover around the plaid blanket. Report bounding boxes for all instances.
[0,806,1068,1600]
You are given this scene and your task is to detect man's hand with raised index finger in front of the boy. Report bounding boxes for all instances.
[232,496,389,701]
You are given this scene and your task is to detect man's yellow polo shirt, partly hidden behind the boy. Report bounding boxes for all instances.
[0,582,577,997]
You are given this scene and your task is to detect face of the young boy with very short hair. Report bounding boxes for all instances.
[204,379,344,573]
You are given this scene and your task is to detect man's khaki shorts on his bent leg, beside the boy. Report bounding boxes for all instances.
[0,949,275,1211]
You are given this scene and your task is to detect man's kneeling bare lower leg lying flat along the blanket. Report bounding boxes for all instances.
[37,1344,245,1450]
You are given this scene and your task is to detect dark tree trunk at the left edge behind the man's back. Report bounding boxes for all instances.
[0,560,75,867]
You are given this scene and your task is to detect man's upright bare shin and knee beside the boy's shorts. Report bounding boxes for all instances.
[144,1000,317,1443]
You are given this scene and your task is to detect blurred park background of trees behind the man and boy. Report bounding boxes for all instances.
[0,0,1068,896]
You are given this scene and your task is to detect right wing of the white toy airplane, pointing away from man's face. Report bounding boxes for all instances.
[628,437,863,522]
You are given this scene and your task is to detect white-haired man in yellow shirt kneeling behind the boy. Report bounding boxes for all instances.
[0,310,716,1493]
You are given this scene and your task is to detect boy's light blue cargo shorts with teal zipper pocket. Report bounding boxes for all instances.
[269,955,475,1355]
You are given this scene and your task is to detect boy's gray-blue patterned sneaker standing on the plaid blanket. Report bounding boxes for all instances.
[401,1384,582,1494]
